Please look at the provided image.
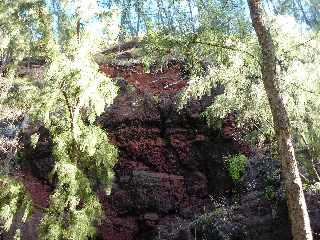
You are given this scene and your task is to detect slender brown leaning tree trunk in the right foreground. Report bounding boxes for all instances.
[248,0,312,240]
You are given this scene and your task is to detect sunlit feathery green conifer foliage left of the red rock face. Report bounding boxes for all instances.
[0,0,117,240]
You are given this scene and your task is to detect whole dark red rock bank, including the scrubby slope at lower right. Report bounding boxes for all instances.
[13,62,320,240]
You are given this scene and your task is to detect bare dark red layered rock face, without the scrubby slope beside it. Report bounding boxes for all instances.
[99,63,234,240]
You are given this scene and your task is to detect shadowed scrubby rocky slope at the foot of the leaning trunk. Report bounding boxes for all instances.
[182,155,320,240]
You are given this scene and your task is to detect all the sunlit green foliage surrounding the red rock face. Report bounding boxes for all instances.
[0,0,320,239]
